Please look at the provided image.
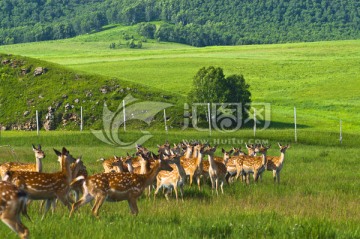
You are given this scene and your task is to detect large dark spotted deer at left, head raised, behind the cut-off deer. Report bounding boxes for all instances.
[5,148,78,217]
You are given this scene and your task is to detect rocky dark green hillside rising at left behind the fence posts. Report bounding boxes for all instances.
[0,54,182,130]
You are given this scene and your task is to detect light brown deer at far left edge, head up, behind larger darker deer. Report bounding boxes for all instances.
[0,144,45,178]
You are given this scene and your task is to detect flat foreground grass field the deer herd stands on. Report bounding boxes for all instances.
[0,130,360,239]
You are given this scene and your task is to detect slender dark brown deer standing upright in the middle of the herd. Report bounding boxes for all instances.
[200,146,229,195]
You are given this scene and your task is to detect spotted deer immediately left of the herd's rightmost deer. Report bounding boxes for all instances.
[241,145,270,184]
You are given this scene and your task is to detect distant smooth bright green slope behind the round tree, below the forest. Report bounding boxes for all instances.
[0,23,360,132]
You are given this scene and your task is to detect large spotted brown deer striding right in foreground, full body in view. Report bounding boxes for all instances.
[70,156,173,217]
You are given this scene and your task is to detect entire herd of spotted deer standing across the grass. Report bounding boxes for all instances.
[0,141,290,238]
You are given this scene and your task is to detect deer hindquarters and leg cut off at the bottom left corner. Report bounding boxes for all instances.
[0,181,30,239]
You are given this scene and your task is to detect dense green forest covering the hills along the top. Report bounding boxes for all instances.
[0,0,360,46]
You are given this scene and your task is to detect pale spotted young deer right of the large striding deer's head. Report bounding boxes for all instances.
[154,151,186,202]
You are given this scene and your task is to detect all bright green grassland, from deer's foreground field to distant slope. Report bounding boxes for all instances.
[0,26,360,239]
